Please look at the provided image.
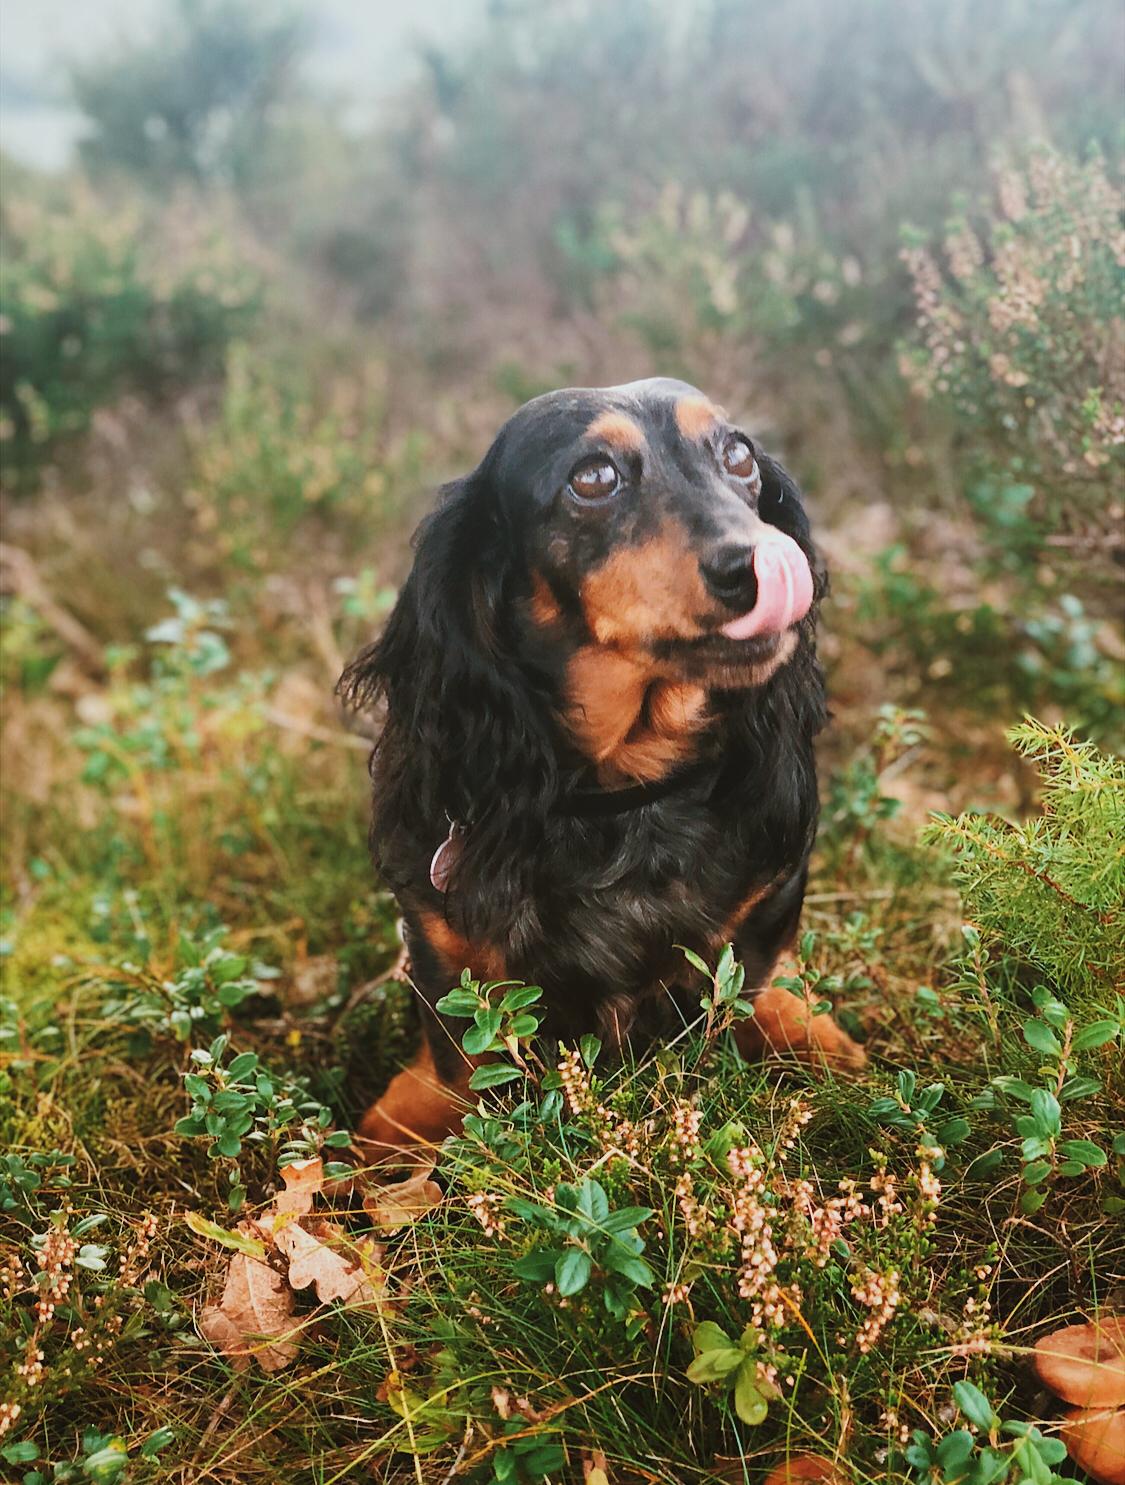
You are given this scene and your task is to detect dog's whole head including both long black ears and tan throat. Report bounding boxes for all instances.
[343,379,824,896]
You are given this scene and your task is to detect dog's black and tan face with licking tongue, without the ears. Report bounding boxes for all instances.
[473,379,824,689]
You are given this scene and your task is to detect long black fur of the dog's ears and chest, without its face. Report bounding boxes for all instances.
[341,383,827,1071]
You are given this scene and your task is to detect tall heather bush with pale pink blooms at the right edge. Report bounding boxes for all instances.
[901,150,1125,555]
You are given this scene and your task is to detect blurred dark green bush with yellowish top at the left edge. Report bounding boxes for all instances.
[0,190,260,484]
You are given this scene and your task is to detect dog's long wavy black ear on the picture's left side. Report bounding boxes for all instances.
[340,471,557,925]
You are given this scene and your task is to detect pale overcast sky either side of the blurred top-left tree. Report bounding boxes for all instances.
[0,0,484,169]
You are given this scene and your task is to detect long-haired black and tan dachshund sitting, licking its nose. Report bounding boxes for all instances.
[341,379,864,1158]
